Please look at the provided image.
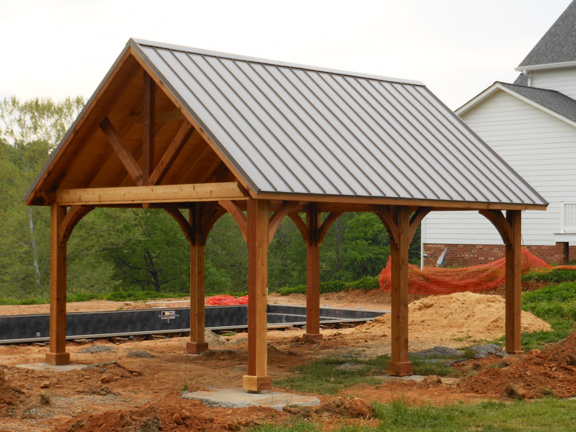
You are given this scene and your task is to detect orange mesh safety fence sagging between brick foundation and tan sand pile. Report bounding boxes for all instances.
[378,249,576,295]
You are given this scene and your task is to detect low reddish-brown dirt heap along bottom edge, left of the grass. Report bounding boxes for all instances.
[56,397,287,432]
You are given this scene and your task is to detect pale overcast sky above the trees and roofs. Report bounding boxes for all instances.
[0,0,571,109]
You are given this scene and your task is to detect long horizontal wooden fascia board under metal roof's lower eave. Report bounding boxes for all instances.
[257,192,548,211]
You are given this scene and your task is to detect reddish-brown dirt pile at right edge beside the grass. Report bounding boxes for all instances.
[458,333,576,399]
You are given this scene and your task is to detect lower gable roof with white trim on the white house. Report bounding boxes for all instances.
[456,81,576,127]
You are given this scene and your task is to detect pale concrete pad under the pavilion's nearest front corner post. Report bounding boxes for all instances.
[182,387,320,410]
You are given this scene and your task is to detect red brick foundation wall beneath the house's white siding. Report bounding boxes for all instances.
[424,243,576,267]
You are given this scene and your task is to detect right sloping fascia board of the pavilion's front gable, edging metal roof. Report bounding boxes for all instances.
[129,43,256,198]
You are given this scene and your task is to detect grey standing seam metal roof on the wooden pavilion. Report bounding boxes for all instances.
[129,40,546,205]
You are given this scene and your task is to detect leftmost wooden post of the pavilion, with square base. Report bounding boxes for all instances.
[46,203,70,365]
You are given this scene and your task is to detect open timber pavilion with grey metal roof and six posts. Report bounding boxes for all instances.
[26,40,547,392]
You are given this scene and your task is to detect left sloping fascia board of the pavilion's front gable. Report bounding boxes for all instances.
[25,47,132,205]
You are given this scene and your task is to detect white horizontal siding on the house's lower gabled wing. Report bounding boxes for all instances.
[422,91,576,264]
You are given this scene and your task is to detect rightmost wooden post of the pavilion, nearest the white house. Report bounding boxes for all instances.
[506,210,522,354]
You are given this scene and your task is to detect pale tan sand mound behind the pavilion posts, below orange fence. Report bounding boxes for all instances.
[357,292,551,340]
